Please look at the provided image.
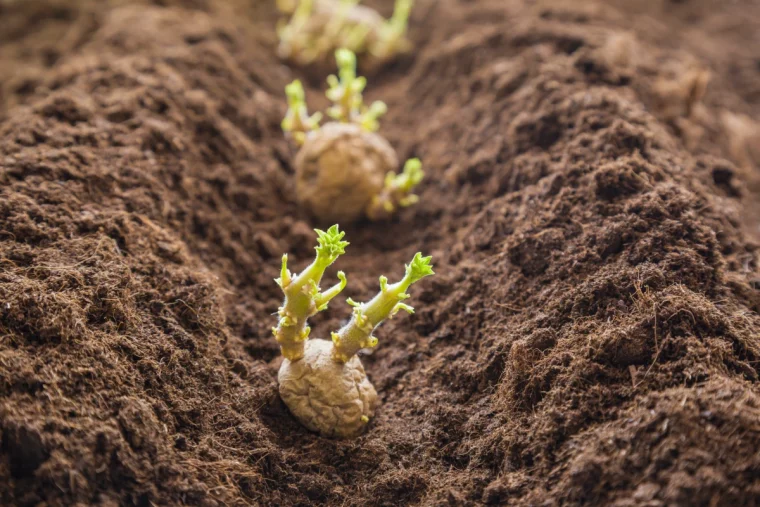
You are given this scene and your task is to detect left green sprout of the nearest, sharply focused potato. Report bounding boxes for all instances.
[272,225,348,361]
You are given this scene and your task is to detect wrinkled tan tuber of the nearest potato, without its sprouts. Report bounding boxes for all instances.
[277,339,377,438]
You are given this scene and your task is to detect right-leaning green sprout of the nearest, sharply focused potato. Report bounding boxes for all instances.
[332,252,434,363]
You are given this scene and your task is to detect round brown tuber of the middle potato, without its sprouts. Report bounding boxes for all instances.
[295,122,398,224]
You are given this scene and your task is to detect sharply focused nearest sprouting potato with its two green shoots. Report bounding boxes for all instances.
[275,240,433,438]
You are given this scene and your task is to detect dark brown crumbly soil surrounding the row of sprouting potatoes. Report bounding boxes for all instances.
[0,0,760,506]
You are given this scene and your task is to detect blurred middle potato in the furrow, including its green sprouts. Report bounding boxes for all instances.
[282,49,424,223]
